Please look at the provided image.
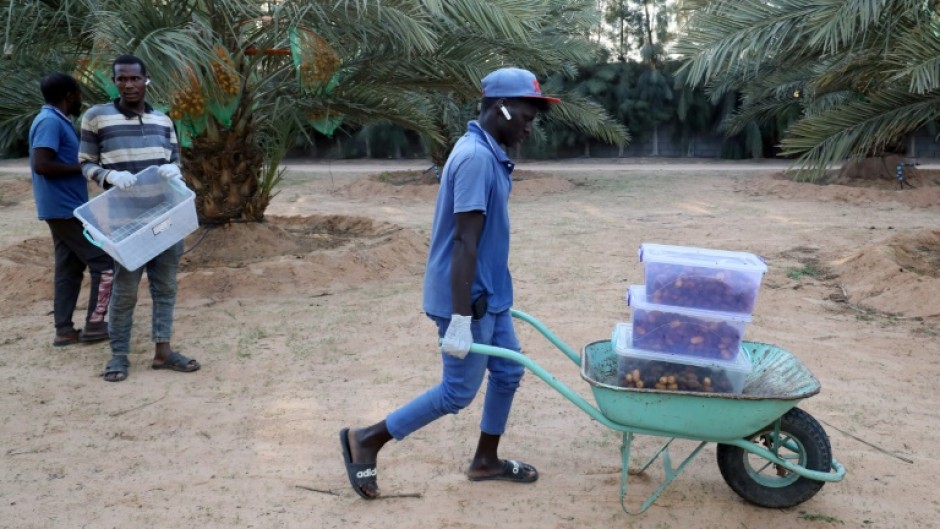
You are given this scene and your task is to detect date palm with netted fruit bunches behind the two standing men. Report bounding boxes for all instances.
[0,0,626,223]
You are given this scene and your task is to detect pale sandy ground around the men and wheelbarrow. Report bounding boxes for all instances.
[0,161,940,529]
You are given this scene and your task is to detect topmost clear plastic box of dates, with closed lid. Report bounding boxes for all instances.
[640,243,767,314]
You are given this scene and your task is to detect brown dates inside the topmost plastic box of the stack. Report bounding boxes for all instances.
[646,263,760,313]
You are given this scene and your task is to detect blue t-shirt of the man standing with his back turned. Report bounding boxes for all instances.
[29,105,88,220]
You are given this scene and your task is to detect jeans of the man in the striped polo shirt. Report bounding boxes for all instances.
[108,241,183,355]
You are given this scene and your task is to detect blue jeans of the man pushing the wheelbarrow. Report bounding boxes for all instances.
[385,310,525,441]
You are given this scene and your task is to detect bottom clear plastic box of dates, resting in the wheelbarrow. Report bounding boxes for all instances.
[611,323,751,393]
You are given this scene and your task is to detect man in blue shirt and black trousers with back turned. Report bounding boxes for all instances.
[29,73,114,346]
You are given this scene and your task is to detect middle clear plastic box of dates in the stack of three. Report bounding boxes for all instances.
[627,285,751,360]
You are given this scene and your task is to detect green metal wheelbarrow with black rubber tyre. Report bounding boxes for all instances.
[470,310,845,514]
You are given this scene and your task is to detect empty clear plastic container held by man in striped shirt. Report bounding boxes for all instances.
[75,166,199,270]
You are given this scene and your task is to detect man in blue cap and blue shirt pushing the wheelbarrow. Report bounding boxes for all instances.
[339,68,559,499]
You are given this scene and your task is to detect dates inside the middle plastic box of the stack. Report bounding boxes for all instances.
[633,309,741,360]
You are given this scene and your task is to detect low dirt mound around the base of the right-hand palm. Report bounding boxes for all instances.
[739,170,940,208]
